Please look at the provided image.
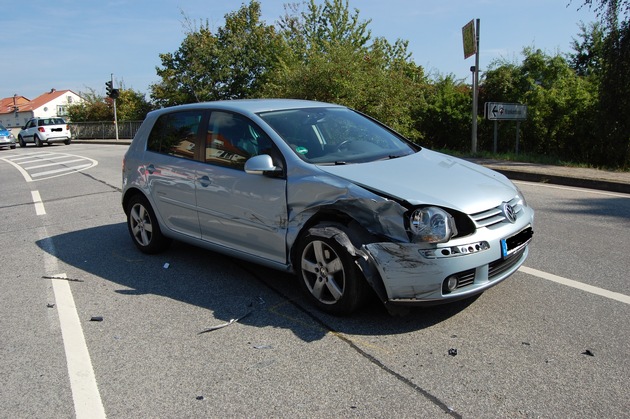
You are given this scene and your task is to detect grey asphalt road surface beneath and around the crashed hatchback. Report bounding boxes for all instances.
[0,144,630,418]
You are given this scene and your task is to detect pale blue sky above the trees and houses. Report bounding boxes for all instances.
[0,0,596,99]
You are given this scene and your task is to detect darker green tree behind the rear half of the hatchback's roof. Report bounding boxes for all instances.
[150,1,281,106]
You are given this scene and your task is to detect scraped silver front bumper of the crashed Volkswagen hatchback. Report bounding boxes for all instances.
[362,225,533,305]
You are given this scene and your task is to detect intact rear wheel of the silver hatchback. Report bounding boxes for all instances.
[127,195,171,254]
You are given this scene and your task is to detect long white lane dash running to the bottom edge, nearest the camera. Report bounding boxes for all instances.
[40,233,106,419]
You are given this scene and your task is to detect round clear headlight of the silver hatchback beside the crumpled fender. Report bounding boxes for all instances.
[409,207,457,243]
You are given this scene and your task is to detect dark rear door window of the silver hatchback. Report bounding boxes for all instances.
[147,111,203,160]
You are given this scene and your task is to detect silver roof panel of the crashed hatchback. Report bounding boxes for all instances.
[152,99,343,118]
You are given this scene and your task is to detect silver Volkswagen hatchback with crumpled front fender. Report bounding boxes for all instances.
[122,99,534,314]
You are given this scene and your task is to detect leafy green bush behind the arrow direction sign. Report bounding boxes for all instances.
[481,47,597,161]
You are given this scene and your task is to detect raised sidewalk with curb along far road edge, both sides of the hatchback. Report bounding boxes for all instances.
[72,139,630,194]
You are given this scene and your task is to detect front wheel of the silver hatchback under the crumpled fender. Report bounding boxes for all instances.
[296,225,366,315]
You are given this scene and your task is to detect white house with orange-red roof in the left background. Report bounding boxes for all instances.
[0,89,83,129]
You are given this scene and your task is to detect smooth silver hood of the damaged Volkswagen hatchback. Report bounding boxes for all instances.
[318,149,517,214]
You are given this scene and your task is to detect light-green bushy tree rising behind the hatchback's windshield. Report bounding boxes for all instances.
[264,0,425,139]
